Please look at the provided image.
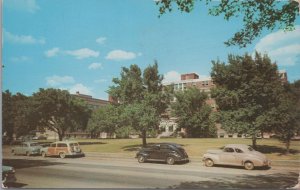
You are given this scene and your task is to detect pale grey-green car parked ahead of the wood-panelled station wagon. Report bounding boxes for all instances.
[11,142,42,156]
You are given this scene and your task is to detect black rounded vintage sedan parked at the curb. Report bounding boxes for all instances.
[136,143,189,165]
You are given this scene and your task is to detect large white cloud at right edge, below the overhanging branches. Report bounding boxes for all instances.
[255,26,300,66]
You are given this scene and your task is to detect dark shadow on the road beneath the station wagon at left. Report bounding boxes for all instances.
[2,159,65,169]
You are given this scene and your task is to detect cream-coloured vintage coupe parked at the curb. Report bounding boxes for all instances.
[202,144,271,170]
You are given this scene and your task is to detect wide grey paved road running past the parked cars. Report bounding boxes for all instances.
[3,156,299,189]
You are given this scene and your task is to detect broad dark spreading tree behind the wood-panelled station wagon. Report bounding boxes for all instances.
[31,88,91,140]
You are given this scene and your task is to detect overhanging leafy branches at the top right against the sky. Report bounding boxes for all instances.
[156,0,299,47]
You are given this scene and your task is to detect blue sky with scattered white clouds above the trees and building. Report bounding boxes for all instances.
[2,0,300,99]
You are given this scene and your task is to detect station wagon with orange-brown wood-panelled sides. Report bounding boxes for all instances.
[41,141,84,158]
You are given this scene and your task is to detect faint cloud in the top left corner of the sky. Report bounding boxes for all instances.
[3,0,40,13]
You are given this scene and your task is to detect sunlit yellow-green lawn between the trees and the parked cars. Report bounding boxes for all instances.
[73,138,300,160]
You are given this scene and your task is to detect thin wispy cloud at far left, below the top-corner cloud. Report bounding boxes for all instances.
[3,30,46,44]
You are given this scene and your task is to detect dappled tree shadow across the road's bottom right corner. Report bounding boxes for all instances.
[168,172,298,189]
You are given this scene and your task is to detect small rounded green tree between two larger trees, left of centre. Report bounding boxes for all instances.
[87,105,121,136]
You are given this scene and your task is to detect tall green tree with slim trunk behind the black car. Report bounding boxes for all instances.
[108,62,169,146]
